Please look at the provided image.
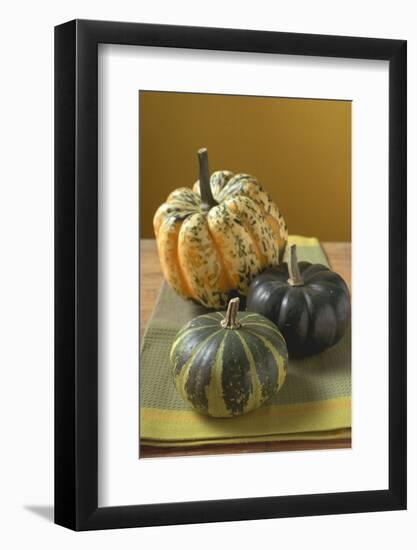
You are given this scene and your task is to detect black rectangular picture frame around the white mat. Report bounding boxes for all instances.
[55,20,407,530]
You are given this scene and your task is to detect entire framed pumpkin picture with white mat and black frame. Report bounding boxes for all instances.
[55,20,406,530]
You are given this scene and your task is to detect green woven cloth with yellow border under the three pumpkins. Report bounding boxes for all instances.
[140,236,351,446]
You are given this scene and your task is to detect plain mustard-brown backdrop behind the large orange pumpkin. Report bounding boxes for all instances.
[139,91,351,241]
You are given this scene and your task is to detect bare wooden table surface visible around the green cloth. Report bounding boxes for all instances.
[140,239,351,458]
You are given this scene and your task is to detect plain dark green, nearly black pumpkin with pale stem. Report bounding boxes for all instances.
[247,245,350,357]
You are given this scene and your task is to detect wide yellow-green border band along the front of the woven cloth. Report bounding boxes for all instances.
[140,396,351,442]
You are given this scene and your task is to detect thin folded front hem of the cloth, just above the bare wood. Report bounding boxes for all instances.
[141,428,351,447]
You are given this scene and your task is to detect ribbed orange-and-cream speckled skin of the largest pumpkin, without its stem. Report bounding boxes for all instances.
[154,171,287,309]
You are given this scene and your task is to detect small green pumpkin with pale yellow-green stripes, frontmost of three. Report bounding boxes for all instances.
[171,298,288,417]
